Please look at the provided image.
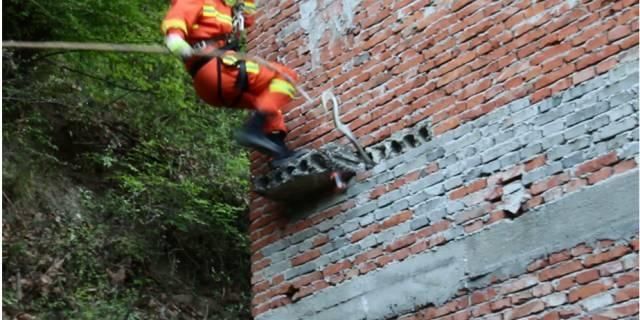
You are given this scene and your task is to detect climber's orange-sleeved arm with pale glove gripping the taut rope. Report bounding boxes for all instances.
[162,0,203,57]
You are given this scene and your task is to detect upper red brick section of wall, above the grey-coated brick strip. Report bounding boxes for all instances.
[250,0,638,158]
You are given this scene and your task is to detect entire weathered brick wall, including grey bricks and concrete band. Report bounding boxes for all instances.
[244,0,638,319]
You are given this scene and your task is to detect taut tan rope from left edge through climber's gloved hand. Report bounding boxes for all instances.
[2,40,313,102]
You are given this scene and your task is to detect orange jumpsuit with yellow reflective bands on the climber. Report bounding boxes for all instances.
[162,0,297,134]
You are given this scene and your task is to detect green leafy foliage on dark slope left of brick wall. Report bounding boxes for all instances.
[2,0,255,319]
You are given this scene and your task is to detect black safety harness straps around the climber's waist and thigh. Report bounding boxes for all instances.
[189,0,249,107]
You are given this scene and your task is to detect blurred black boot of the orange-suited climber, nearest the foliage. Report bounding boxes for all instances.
[236,112,289,158]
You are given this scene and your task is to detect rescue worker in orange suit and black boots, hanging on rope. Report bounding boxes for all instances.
[162,0,297,161]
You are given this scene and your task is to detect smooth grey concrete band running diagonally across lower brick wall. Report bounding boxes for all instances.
[256,170,638,320]
